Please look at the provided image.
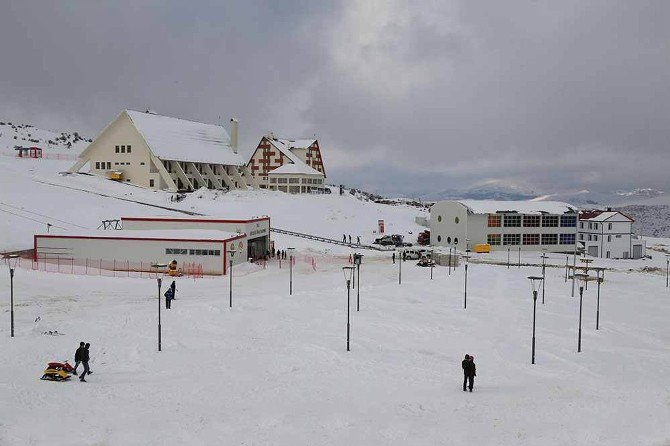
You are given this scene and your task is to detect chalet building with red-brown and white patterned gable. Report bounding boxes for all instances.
[247,134,326,194]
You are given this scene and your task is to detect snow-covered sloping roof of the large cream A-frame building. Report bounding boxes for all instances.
[126,110,245,166]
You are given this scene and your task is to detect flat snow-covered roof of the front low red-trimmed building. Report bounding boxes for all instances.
[36,229,240,241]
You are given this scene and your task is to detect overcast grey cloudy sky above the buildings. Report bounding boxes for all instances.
[0,0,670,193]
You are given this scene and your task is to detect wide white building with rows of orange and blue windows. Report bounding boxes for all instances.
[430,200,577,252]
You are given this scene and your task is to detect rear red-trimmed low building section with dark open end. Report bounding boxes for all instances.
[121,216,271,260]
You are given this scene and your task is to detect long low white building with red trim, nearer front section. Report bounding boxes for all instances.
[33,229,247,275]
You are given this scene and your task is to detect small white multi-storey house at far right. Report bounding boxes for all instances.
[578,208,647,259]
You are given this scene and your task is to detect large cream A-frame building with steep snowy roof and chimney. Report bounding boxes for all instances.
[69,110,259,192]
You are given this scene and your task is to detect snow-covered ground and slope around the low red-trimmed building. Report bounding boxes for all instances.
[0,138,670,446]
